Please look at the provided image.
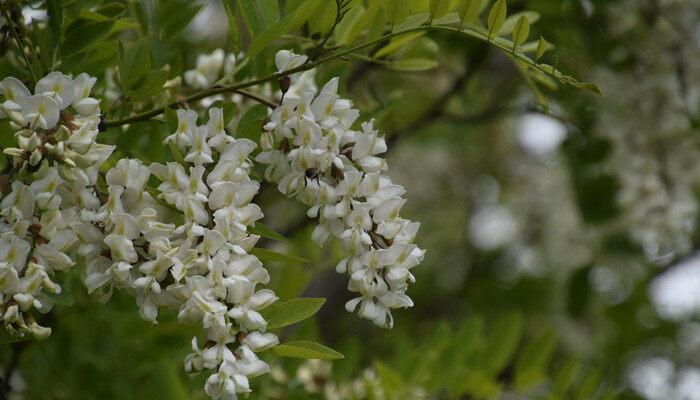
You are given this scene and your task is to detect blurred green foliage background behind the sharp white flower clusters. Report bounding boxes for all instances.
[0,0,700,400]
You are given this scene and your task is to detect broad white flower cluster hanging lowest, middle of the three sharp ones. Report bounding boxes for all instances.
[86,108,278,399]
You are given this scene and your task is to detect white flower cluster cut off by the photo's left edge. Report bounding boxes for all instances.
[0,72,114,339]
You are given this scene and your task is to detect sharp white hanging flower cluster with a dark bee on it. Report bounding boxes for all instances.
[256,53,425,328]
